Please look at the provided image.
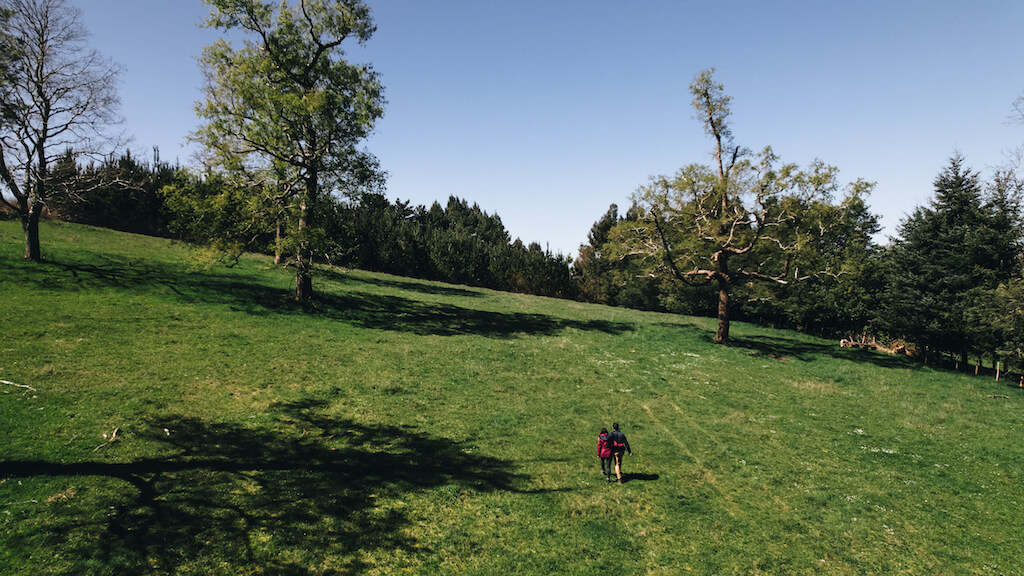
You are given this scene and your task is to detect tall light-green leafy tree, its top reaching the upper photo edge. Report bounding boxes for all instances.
[196,0,384,300]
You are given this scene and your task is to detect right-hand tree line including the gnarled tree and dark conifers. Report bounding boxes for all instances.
[573,70,1024,371]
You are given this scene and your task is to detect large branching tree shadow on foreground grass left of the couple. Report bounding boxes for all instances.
[6,401,529,576]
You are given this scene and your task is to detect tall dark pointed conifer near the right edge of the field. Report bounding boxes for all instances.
[883,155,1022,362]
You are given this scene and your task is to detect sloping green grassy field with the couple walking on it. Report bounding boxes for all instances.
[0,217,1024,575]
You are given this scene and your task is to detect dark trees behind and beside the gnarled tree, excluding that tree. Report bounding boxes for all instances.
[573,155,1024,368]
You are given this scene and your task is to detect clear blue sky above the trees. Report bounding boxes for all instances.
[71,0,1024,254]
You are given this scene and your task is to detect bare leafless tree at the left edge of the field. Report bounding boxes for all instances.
[0,0,121,260]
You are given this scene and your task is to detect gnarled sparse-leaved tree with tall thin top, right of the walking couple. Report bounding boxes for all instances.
[631,70,872,342]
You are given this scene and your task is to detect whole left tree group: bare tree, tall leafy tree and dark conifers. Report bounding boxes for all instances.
[0,0,575,300]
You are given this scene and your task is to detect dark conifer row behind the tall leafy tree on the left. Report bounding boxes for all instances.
[0,144,577,298]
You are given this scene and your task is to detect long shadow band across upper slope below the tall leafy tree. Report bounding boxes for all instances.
[11,256,634,338]
